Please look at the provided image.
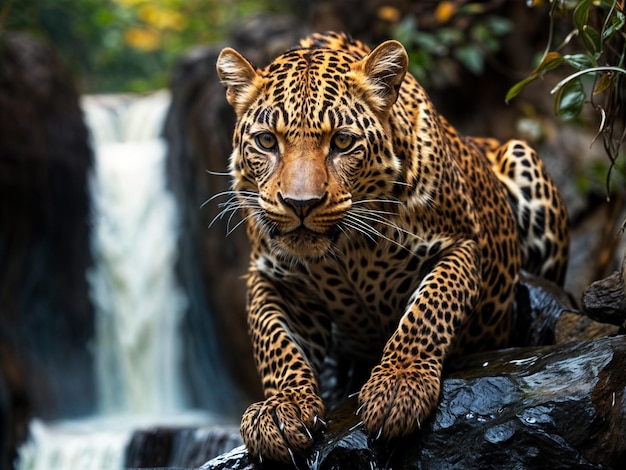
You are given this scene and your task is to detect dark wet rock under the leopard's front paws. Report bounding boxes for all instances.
[201,336,626,470]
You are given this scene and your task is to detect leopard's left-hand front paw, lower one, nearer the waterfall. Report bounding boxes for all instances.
[241,387,324,463]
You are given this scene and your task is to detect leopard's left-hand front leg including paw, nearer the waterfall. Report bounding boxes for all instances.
[241,272,330,462]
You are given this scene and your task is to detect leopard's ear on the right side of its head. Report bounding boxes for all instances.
[361,41,409,113]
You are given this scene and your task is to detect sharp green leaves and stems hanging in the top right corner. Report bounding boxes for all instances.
[506,0,626,194]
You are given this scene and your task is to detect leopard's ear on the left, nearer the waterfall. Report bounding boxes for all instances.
[216,47,259,117]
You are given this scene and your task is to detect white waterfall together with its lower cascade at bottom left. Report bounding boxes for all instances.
[16,92,206,470]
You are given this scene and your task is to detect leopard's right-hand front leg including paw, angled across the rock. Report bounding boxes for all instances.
[359,240,481,440]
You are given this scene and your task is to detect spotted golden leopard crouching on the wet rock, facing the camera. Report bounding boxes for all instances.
[216,32,569,463]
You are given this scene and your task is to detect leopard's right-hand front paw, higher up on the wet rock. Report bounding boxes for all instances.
[357,364,441,441]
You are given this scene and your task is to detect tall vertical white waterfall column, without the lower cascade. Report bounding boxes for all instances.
[85,92,186,413]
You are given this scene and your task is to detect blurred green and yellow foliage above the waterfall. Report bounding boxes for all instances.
[0,0,294,93]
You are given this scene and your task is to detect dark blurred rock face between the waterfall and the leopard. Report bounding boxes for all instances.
[165,42,258,414]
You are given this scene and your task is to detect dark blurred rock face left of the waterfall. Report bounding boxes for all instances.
[0,34,95,466]
